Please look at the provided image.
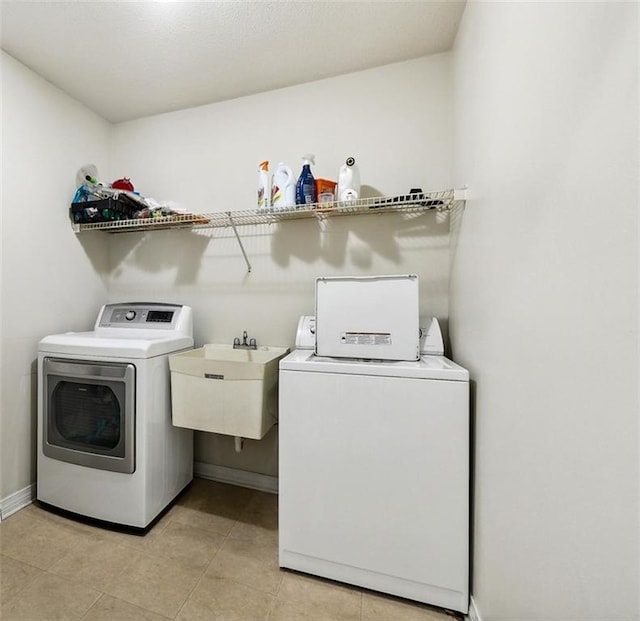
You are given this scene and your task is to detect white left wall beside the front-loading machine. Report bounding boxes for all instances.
[0,52,109,499]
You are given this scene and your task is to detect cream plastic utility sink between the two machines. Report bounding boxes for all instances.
[169,344,289,440]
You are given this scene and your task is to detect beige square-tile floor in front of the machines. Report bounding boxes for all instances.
[0,479,461,621]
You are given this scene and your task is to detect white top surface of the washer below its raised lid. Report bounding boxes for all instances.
[280,349,469,382]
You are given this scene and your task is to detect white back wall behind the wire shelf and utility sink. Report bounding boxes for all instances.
[109,54,452,474]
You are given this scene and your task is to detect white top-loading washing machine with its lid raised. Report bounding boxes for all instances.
[279,279,470,613]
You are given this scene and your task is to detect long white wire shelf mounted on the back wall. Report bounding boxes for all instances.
[72,190,464,233]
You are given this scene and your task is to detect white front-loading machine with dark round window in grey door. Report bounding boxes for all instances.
[37,302,193,531]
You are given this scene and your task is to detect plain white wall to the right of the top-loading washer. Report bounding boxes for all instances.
[450,2,640,621]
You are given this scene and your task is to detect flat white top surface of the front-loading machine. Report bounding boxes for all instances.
[38,332,193,358]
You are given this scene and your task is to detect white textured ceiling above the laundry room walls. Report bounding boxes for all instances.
[0,0,464,123]
